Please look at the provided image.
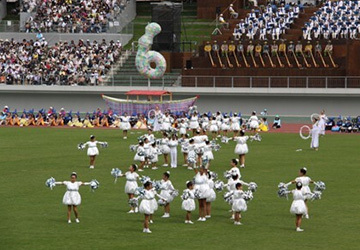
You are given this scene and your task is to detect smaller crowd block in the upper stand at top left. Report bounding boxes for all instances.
[22,0,129,33]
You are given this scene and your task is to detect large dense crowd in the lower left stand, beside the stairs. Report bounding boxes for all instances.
[0,38,122,85]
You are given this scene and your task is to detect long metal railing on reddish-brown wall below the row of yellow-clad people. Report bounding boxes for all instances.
[181,76,360,88]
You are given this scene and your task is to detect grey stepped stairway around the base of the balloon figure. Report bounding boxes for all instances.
[107,52,181,87]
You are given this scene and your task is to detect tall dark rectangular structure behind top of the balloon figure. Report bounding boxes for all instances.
[151,2,182,52]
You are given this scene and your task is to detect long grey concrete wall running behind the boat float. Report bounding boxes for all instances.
[0,86,360,116]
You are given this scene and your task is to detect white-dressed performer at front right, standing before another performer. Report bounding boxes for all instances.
[289,182,307,232]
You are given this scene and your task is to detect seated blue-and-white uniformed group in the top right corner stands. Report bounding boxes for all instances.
[303,0,360,40]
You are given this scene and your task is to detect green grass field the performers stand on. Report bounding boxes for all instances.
[0,127,360,249]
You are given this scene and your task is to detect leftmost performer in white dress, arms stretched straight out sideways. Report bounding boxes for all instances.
[55,172,90,224]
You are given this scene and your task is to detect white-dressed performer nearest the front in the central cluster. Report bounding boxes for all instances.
[139,181,166,233]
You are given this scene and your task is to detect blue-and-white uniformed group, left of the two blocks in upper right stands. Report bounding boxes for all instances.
[229,4,303,40]
